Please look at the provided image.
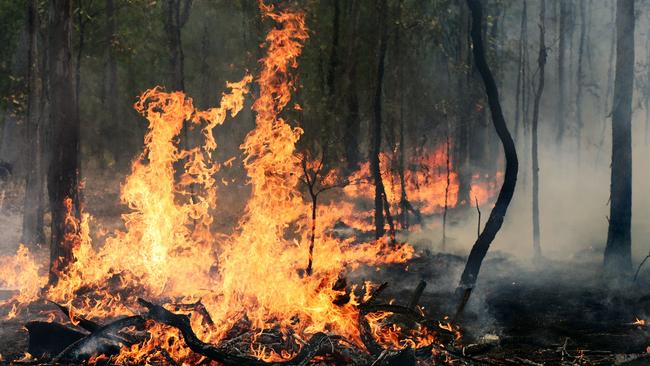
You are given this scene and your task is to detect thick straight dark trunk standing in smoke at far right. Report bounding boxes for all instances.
[604,0,634,278]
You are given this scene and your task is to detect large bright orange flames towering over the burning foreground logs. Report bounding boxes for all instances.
[0,2,429,364]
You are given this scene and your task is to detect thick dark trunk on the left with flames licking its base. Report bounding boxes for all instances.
[48,0,79,283]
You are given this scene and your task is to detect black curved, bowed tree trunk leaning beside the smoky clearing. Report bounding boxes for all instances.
[457,0,519,316]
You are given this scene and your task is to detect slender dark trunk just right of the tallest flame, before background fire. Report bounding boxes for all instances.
[370,0,388,239]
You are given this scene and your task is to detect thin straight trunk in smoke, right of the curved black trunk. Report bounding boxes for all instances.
[531,0,546,259]
